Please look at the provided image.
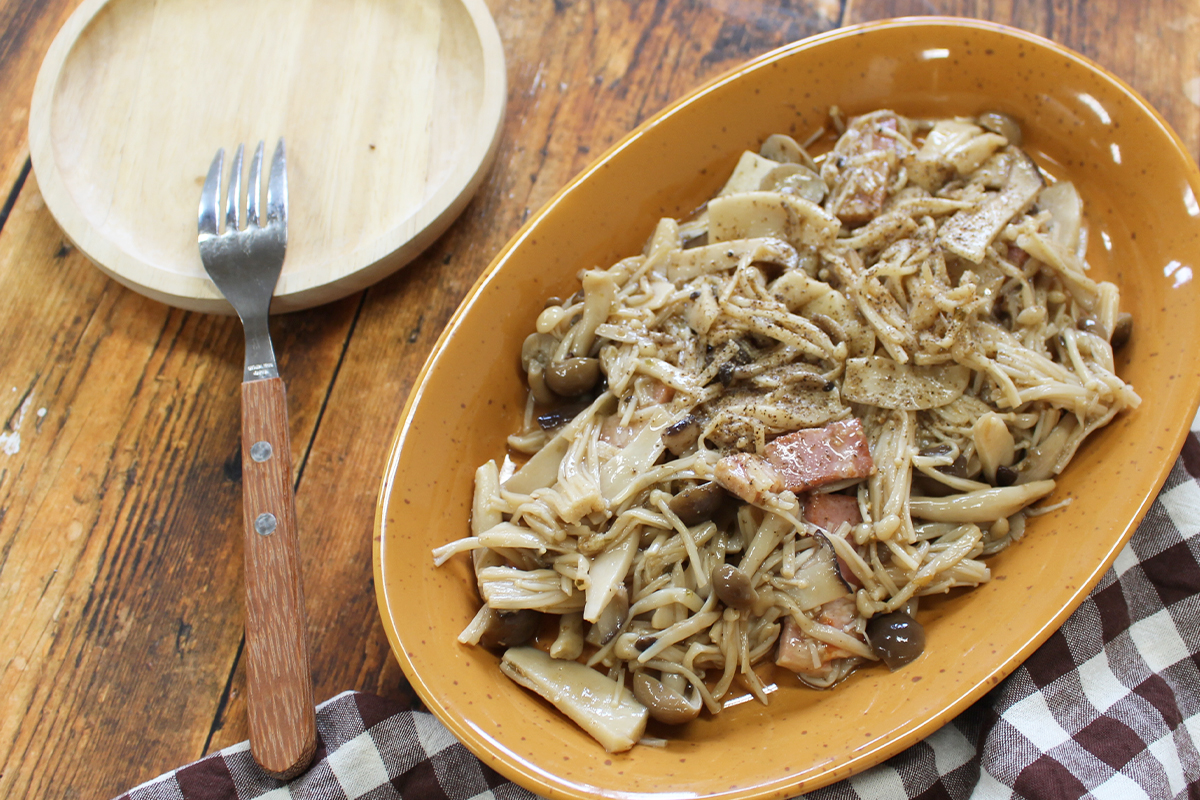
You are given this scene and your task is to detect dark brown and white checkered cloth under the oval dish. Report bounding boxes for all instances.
[119,416,1200,800]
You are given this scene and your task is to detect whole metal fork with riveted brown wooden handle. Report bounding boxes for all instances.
[198,139,317,778]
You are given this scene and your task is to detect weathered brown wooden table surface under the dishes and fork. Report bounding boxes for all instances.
[0,0,1200,800]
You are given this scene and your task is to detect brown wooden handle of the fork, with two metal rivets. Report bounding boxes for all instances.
[241,378,317,778]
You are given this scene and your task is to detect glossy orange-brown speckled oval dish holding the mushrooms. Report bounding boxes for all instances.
[376,18,1200,800]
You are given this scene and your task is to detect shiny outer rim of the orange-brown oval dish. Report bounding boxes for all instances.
[373,16,1200,800]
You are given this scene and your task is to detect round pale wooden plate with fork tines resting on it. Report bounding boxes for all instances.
[29,0,505,313]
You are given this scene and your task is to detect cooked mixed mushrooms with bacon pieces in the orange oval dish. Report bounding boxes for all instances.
[434,109,1139,752]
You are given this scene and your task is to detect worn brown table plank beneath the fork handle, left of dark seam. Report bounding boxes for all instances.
[0,172,356,798]
